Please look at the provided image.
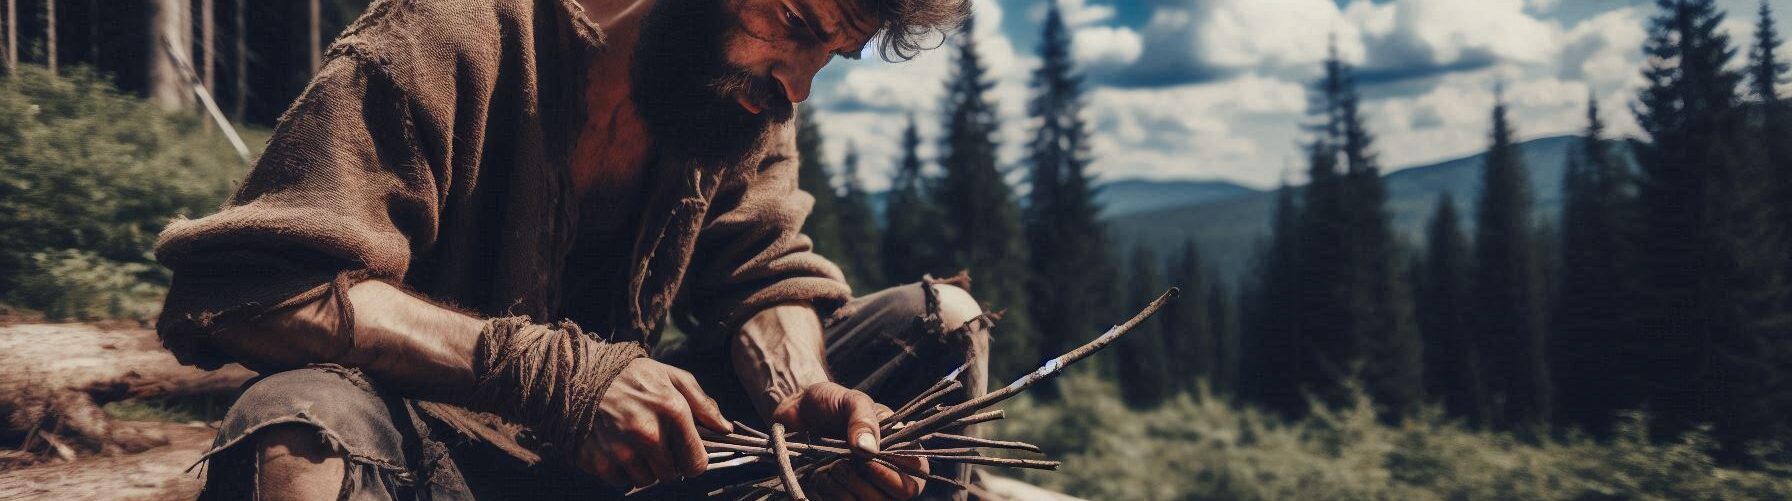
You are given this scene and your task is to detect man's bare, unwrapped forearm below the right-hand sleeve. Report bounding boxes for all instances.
[731,304,830,417]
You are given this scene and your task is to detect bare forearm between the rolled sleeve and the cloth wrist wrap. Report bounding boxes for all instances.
[217,281,486,403]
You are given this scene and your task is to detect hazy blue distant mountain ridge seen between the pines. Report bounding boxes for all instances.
[1107,136,1627,286]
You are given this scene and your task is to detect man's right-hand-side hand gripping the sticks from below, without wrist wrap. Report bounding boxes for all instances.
[772,383,928,501]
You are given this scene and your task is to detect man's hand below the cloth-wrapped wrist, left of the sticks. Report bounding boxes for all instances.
[577,358,733,487]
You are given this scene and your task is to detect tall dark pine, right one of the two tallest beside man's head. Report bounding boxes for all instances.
[1023,4,1115,395]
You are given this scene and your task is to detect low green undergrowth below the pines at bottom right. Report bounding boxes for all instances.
[993,373,1792,499]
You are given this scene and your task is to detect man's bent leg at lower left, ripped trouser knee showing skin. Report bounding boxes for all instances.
[201,367,464,499]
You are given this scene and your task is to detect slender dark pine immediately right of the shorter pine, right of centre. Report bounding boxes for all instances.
[1475,93,1550,431]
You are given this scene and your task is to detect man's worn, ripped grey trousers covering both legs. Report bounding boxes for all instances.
[201,284,989,499]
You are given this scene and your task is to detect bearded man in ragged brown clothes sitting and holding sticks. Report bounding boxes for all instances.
[156,0,987,499]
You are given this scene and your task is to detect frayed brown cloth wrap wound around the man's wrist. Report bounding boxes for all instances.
[468,317,647,451]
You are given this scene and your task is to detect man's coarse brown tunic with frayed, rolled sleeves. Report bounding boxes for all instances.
[156,0,851,367]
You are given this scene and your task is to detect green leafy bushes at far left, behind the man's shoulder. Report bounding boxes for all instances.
[0,66,256,318]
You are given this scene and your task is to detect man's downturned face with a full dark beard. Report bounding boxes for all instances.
[631,0,878,159]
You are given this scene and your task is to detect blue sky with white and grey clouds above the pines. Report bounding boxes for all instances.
[805,0,1792,190]
